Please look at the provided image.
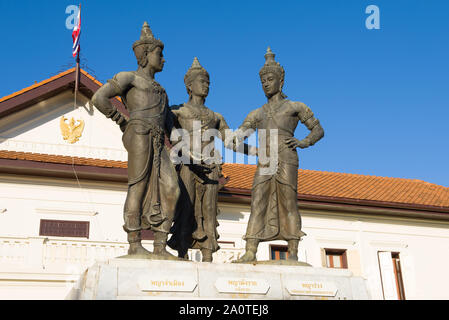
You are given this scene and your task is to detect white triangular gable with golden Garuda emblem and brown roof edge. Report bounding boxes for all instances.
[0,71,127,161]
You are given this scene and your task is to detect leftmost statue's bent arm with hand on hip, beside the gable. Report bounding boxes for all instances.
[92,72,132,132]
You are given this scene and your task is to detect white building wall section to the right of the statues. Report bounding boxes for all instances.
[296,212,449,299]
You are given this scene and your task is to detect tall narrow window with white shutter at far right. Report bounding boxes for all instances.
[378,251,405,300]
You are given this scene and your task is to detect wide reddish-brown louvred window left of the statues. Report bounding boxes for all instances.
[39,219,89,238]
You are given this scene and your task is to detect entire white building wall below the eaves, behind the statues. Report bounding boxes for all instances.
[0,175,449,299]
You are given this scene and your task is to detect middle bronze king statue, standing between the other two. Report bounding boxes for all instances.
[168,57,257,262]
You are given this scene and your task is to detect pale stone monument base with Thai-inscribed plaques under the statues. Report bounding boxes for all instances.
[67,258,369,300]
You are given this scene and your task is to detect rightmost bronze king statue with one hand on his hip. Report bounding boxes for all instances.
[235,48,324,263]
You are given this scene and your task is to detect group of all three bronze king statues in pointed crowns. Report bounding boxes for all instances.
[92,22,324,263]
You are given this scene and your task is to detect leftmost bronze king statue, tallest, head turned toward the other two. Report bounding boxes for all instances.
[92,22,180,260]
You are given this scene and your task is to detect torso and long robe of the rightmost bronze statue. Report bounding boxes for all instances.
[240,100,316,241]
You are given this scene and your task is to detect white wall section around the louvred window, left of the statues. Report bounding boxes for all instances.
[0,176,127,241]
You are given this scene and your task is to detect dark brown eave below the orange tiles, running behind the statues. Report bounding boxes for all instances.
[0,159,449,221]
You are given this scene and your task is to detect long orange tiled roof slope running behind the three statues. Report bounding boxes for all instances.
[0,151,449,209]
